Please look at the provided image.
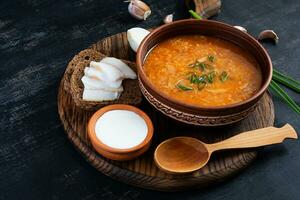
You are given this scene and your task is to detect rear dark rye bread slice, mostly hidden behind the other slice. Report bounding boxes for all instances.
[64,49,106,92]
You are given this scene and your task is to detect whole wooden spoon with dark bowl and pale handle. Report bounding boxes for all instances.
[154,124,298,173]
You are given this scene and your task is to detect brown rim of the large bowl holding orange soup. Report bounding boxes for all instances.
[136,19,273,111]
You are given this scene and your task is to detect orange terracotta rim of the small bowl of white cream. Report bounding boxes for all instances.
[87,104,153,154]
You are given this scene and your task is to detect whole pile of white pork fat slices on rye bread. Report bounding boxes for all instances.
[81,57,137,101]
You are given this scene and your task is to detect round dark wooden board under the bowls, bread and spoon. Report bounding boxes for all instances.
[58,33,274,191]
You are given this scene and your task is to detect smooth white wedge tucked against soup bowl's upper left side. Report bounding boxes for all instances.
[127,27,150,52]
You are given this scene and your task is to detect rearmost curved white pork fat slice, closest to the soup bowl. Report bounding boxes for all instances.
[100,57,136,79]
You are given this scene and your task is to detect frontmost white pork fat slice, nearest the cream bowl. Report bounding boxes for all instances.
[82,89,120,101]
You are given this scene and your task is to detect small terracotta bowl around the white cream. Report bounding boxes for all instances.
[87,104,153,160]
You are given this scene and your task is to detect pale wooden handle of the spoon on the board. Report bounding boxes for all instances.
[208,124,298,153]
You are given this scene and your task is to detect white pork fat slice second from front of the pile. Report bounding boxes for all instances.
[81,76,123,92]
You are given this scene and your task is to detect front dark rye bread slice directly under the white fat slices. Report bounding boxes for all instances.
[70,60,142,111]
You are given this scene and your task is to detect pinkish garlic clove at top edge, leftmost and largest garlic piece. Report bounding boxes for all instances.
[128,0,151,20]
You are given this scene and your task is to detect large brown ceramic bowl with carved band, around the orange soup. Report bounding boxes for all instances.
[136,19,272,126]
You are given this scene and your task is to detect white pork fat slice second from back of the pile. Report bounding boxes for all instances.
[90,61,124,81]
